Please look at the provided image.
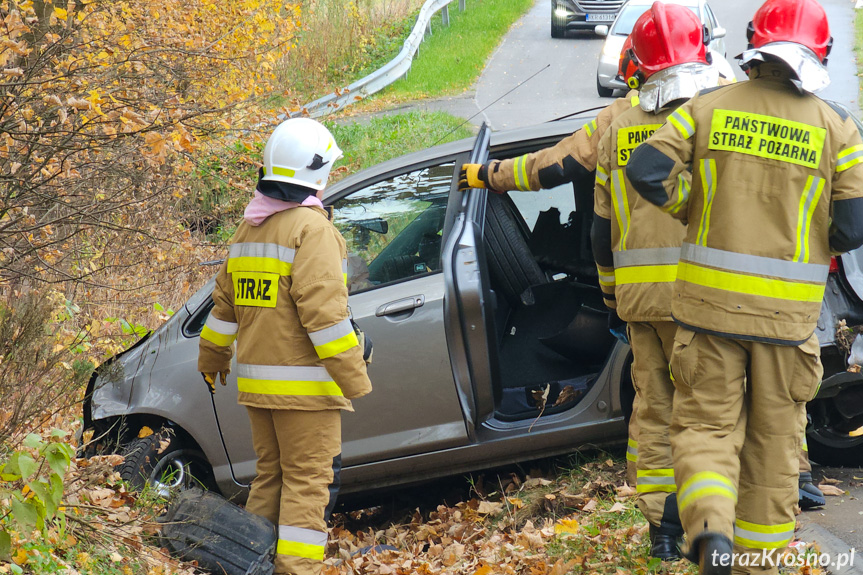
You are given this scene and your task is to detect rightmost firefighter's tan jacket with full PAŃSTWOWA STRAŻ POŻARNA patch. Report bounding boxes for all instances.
[626,63,863,345]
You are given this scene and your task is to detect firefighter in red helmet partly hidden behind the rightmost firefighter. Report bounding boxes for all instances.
[591,2,720,559]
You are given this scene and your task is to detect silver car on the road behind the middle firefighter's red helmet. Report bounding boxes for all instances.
[594,0,726,98]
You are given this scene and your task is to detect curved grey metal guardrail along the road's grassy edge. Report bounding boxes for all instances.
[290,0,465,118]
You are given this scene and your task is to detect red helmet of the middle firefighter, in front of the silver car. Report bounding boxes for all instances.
[630,2,708,79]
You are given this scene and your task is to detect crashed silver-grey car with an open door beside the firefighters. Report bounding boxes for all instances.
[83,111,863,499]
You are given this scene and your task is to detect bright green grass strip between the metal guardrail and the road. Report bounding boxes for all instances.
[383,0,533,100]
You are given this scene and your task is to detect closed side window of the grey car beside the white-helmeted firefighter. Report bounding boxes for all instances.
[333,163,455,293]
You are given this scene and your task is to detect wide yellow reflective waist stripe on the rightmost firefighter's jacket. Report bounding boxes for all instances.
[680,261,824,302]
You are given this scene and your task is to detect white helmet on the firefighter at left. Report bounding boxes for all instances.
[261,118,342,190]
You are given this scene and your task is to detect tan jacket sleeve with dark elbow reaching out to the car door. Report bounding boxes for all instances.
[488,90,638,192]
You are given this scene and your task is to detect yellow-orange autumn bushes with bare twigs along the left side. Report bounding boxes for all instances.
[0,0,308,439]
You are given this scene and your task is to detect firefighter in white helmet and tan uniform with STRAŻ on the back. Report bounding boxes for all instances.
[198,118,371,575]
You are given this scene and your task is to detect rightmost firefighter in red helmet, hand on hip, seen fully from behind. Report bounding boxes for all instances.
[626,0,863,575]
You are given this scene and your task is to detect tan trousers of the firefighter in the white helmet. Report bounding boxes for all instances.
[246,406,342,575]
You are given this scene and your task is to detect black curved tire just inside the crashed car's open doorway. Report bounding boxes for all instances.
[485,193,548,305]
